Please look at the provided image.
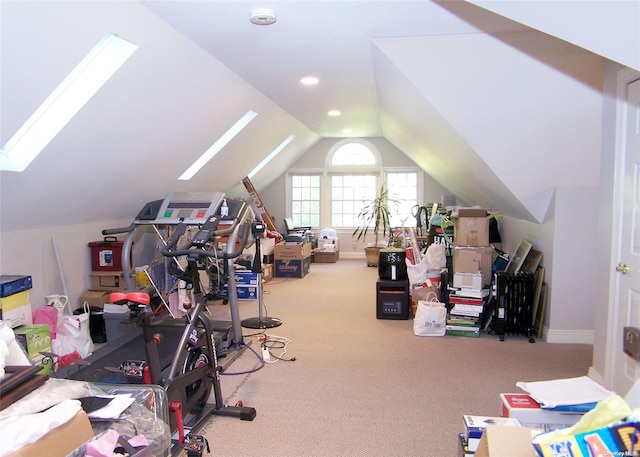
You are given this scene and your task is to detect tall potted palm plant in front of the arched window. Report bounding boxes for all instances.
[351,184,398,267]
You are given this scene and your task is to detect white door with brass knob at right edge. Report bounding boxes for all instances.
[609,79,640,395]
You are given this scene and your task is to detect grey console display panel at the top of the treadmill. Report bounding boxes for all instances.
[152,192,225,225]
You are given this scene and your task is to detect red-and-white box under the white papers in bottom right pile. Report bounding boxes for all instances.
[500,393,584,431]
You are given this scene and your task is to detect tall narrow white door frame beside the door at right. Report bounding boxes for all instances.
[604,68,640,387]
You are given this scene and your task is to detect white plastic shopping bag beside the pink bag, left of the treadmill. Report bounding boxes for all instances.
[52,302,94,359]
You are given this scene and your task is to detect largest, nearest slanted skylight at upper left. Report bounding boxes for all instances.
[0,33,138,171]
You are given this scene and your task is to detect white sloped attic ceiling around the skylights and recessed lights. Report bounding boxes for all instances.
[0,0,640,231]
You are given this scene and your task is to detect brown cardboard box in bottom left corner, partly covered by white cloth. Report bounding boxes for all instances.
[11,410,93,457]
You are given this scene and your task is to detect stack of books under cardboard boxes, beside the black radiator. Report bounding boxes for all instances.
[446,280,489,338]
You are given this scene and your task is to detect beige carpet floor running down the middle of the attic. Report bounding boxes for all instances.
[189,260,592,457]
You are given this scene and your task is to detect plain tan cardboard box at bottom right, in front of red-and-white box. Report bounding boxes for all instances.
[475,425,540,457]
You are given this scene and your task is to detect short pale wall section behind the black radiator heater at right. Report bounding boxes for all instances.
[476,187,599,344]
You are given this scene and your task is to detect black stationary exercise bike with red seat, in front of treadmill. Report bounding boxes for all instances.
[110,216,256,444]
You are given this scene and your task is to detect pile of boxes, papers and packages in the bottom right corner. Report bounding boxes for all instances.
[458,376,640,457]
